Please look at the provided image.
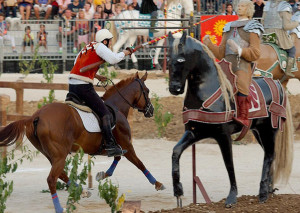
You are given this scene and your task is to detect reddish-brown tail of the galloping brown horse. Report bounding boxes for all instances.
[0,118,33,147]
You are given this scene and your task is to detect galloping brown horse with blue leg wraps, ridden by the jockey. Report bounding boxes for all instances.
[0,73,164,213]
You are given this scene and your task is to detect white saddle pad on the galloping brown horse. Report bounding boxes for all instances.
[73,107,101,132]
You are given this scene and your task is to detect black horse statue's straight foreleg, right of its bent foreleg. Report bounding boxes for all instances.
[215,134,238,208]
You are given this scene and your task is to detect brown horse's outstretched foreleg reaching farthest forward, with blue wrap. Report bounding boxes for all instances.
[125,146,165,191]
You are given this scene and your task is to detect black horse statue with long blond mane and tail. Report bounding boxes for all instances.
[168,30,293,207]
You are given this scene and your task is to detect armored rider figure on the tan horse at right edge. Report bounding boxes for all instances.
[262,0,299,77]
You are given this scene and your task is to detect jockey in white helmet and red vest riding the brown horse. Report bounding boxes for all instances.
[69,29,131,157]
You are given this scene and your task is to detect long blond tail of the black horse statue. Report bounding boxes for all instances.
[273,97,294,183]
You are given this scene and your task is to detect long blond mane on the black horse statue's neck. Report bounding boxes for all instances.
[182,37,234,113]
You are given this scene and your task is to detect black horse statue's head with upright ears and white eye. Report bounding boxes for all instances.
[168,31,193,95]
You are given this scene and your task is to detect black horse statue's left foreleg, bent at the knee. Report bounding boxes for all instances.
[172,130,195,198]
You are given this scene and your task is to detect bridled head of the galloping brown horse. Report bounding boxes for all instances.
[133,72,154,118]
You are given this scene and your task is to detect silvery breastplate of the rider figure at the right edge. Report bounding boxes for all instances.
[264,2,282,29]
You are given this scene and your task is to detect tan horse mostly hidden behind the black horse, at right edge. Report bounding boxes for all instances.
[256,33,300,88]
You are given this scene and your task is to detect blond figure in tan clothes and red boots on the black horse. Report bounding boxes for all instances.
[203,0,263,127]
